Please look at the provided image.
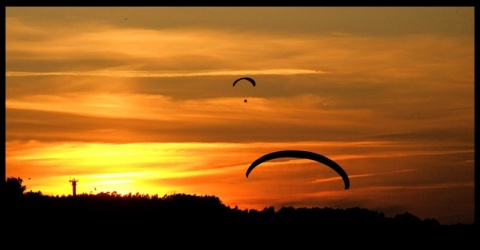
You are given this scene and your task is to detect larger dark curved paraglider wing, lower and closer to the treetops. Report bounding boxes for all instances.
[246,150,350,189]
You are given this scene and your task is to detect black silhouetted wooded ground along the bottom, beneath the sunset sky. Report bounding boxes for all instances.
[2,193,480,249]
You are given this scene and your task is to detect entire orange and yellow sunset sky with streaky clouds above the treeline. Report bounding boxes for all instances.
[5,7,475,224]
